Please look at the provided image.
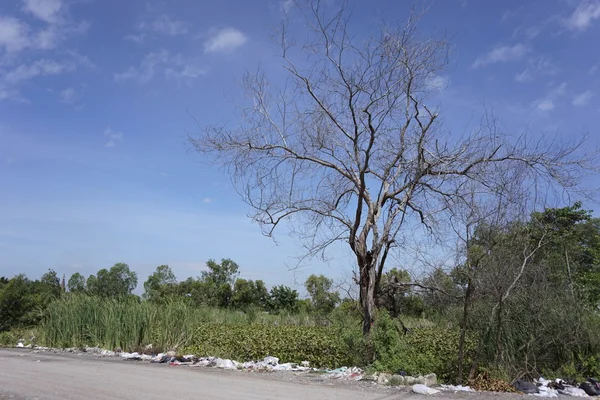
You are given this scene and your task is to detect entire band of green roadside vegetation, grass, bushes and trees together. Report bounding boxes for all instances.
[0,204,600,382]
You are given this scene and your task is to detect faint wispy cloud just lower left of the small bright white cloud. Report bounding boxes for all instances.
[114,50,208,83]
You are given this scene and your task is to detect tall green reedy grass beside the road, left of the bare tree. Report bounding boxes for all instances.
[39,295,317,351]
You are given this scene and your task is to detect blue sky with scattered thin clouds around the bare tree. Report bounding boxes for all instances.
[0,0,600,294]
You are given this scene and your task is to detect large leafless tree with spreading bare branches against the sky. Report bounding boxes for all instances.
[190,1,595,334]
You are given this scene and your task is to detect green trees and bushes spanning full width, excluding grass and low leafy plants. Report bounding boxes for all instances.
[0,203,600,381]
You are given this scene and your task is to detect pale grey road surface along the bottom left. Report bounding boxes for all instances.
[0,349,408,400]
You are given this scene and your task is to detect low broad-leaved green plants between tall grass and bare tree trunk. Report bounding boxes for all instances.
[184,324,350,367]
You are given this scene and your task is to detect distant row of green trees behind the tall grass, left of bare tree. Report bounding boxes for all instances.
[0,259,341,331]
